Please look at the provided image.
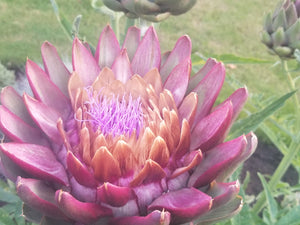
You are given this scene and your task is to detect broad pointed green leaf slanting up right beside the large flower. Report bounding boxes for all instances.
[228,91,296,139]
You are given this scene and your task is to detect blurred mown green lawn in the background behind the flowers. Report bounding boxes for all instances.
[0,0,287,111]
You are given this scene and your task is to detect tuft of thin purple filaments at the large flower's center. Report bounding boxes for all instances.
[85,88,143,137]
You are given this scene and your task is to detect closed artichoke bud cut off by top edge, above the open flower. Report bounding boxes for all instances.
[102,0,197,22]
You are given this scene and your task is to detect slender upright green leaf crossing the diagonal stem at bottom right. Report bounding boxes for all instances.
[257,173,278,224]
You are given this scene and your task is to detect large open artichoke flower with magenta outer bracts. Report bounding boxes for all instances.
[0,26,257,225]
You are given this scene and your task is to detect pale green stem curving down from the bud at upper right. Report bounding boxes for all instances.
[253,60,300,214]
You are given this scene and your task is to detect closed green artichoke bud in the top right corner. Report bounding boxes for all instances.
[261,0,300,58]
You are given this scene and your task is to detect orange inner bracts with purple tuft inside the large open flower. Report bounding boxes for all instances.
[64,68,190,185]
